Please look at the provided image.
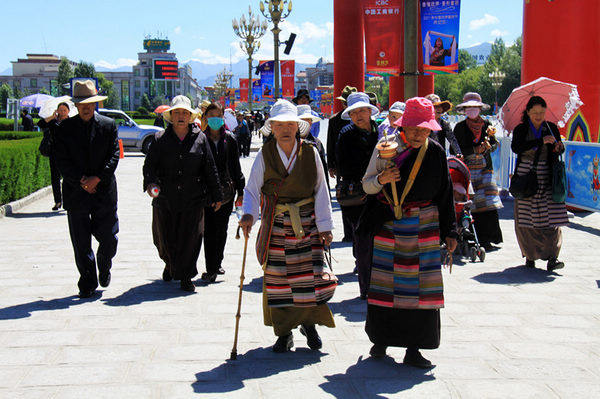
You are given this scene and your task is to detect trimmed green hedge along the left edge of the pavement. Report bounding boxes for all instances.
[0,137,50,204]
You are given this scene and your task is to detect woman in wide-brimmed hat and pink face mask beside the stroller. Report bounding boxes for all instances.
[450,92,502,251]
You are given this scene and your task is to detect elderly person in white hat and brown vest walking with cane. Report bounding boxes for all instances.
[240,100,337,352]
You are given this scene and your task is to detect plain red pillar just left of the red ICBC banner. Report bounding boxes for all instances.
[333,0,365,112]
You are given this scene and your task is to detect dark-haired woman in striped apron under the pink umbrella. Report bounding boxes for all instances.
[511,96,569,271]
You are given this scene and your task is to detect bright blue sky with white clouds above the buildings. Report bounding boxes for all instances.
[0,0,523,72]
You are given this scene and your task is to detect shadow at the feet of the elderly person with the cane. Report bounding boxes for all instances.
[192,347,326,393]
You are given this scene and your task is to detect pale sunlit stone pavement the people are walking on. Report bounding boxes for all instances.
[0,135,600,399]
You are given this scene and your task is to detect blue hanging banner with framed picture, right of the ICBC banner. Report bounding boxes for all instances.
[420,0,460,75]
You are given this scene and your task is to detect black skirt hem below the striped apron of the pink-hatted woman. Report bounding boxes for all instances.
[365,305,441,349]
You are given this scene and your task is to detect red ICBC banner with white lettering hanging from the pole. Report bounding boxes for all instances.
[363,0,404,76]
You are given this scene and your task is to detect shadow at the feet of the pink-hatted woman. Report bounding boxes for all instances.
[319,356,435,399]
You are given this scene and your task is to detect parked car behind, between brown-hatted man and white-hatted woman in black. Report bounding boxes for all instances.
[98,108,162,154]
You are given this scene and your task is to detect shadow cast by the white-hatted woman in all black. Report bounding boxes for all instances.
[103,280,193,306]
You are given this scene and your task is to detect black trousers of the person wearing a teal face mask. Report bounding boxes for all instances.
[204,200,234,273]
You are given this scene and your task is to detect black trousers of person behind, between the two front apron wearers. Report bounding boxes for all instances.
[341,205,373,295]
